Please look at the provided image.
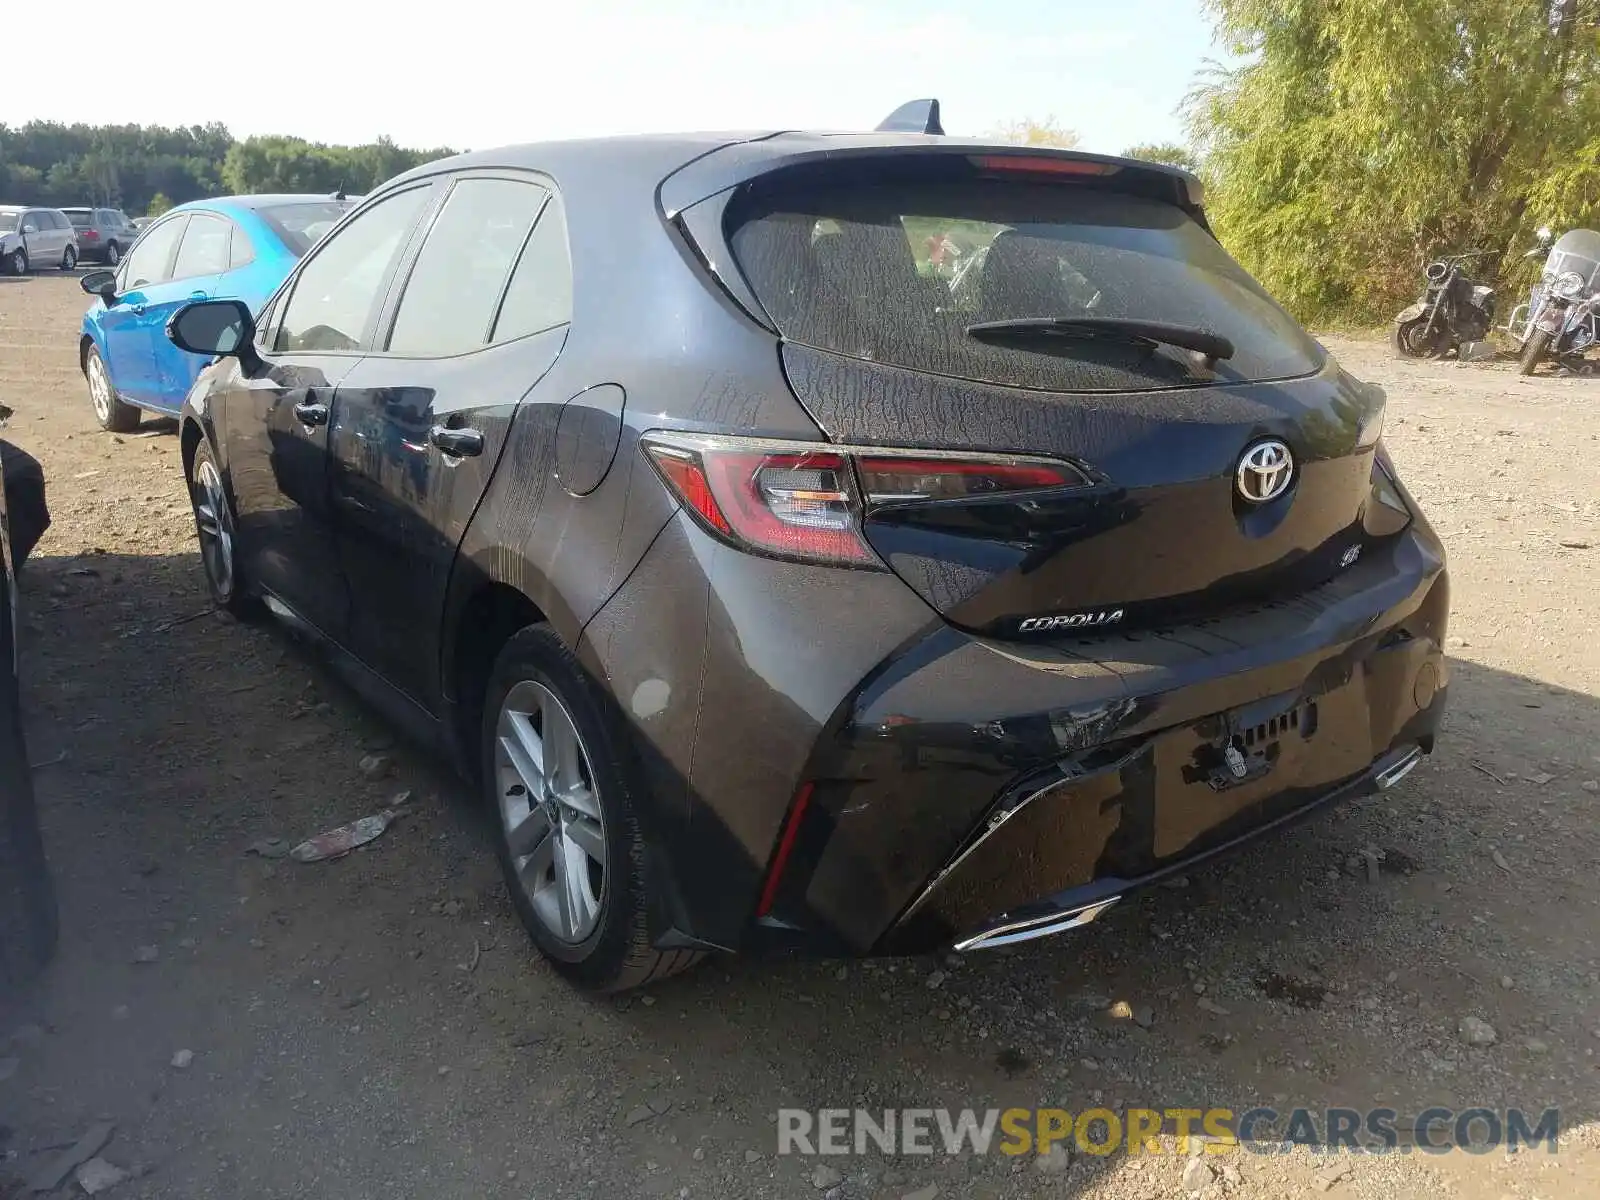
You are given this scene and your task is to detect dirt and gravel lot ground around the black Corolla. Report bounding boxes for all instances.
[0,277,1600,1200]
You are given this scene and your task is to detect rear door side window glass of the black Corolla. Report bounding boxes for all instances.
[389,179,549,358]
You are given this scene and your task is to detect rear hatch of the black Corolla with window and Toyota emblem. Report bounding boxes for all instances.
[682,141,1406,637]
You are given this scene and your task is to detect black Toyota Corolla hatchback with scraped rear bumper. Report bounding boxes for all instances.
[168,115,1448,989]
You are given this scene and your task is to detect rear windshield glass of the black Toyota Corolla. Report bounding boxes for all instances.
[731,181,1322,392]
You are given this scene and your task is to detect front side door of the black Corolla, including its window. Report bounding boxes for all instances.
[214,182,432,642]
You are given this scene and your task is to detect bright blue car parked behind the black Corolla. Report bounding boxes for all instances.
[78,195,360,432]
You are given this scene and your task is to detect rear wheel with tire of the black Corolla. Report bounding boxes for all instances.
[482,626,701,992]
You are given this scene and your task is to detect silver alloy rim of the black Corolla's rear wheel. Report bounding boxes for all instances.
[494,680,608,944]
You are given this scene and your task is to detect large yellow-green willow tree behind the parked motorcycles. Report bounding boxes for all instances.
[1189,0,1600,320]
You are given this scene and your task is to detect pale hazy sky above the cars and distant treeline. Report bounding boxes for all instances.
[0,0,1216,154]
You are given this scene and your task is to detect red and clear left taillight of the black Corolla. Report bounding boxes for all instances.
[642,432,1088,570]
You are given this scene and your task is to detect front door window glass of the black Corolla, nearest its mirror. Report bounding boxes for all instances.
[272,186,430,354]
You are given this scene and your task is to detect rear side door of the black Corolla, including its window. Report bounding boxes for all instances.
[330,173,571,709]
